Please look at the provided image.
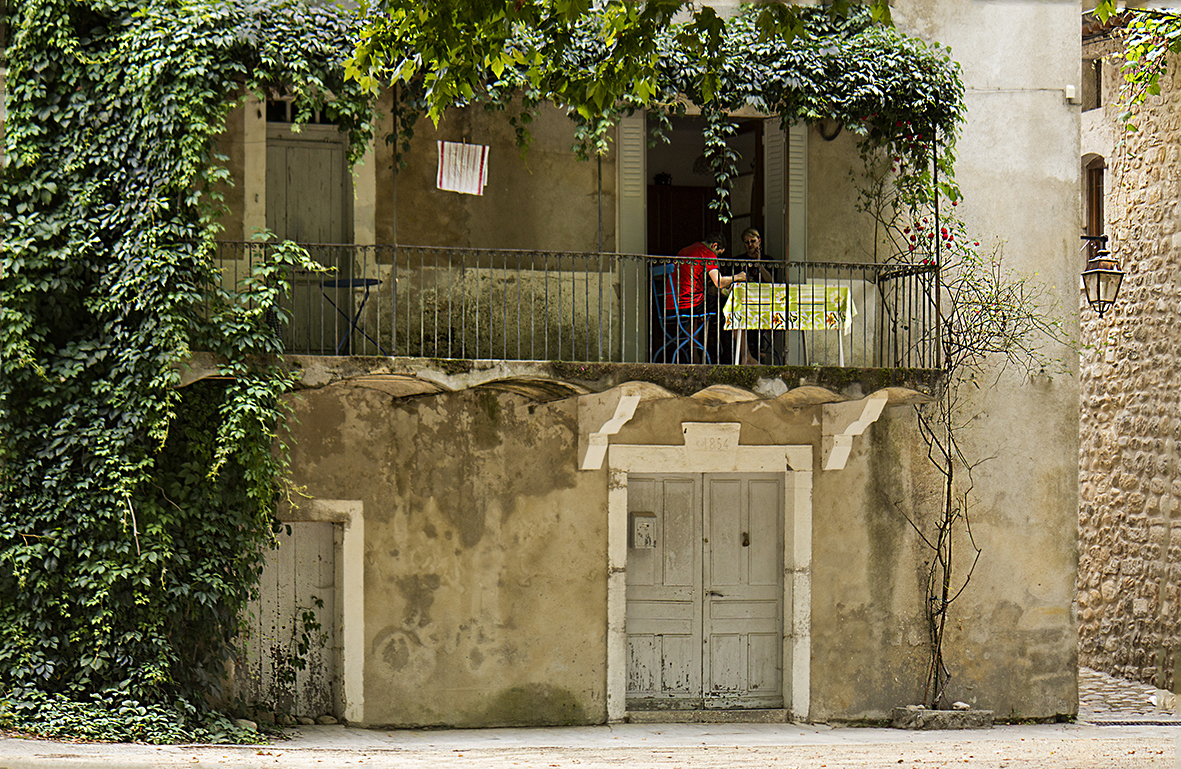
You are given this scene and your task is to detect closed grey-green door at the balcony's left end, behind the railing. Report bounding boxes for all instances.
[267,125,353,353]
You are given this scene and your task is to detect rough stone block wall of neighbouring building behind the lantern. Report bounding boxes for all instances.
[1078,41,1181,687]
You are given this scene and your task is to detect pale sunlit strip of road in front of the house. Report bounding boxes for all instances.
[0,724,1181,769]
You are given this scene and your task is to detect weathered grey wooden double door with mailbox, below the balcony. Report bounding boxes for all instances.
[627,474,784,710]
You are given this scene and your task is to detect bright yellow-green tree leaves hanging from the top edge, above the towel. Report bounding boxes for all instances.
[348,0,890,123]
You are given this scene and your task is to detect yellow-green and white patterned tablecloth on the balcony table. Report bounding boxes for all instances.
[722,284,857,335]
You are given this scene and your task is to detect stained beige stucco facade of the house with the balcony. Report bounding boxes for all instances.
[198,0,1081,726]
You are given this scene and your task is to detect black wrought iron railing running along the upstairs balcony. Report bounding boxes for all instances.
[207,242,939,369]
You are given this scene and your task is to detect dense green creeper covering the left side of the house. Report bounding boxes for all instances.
[0,0,372,738]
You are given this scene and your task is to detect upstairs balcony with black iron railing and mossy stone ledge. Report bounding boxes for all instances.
[196,242,939,403]
